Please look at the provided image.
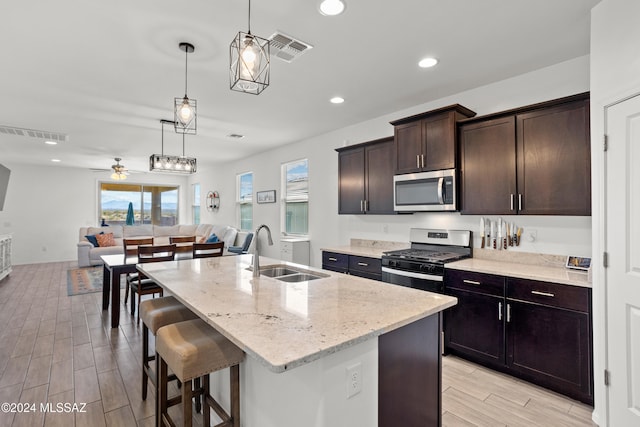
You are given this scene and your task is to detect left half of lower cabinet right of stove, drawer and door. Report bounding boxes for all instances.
[444,270,505,369]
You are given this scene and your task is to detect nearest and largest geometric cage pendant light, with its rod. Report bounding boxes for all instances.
[229,0,271,95]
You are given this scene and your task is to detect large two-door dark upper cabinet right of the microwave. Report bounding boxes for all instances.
[460,93,591,215]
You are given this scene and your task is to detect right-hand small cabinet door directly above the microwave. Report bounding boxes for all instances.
[422,113,456,171]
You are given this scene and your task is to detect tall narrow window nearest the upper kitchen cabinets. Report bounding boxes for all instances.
[282,159,309,235]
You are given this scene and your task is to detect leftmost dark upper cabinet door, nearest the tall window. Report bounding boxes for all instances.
[338,147,365,214]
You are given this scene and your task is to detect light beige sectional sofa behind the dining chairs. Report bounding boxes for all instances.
[78,224,246,267]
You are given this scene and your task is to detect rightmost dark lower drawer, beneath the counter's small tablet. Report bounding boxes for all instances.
[507,277,591,313]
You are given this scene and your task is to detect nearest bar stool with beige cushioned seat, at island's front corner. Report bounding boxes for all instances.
[156,319,244,427]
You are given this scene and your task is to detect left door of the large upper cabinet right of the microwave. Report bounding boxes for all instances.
[460,116,516,215]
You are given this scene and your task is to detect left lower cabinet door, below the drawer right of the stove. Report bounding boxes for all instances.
[444,289,505,368]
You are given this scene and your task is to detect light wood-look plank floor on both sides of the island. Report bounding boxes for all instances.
[0,262,594,427]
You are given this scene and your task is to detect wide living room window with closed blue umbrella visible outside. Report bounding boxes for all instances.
[99,182,178,225]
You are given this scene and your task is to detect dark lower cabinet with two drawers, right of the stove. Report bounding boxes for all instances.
[444,270,593,404]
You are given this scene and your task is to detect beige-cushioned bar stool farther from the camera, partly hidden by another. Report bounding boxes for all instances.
[138,296,198,406]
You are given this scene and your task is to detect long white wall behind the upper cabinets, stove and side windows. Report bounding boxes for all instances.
[190,56,591,266]
